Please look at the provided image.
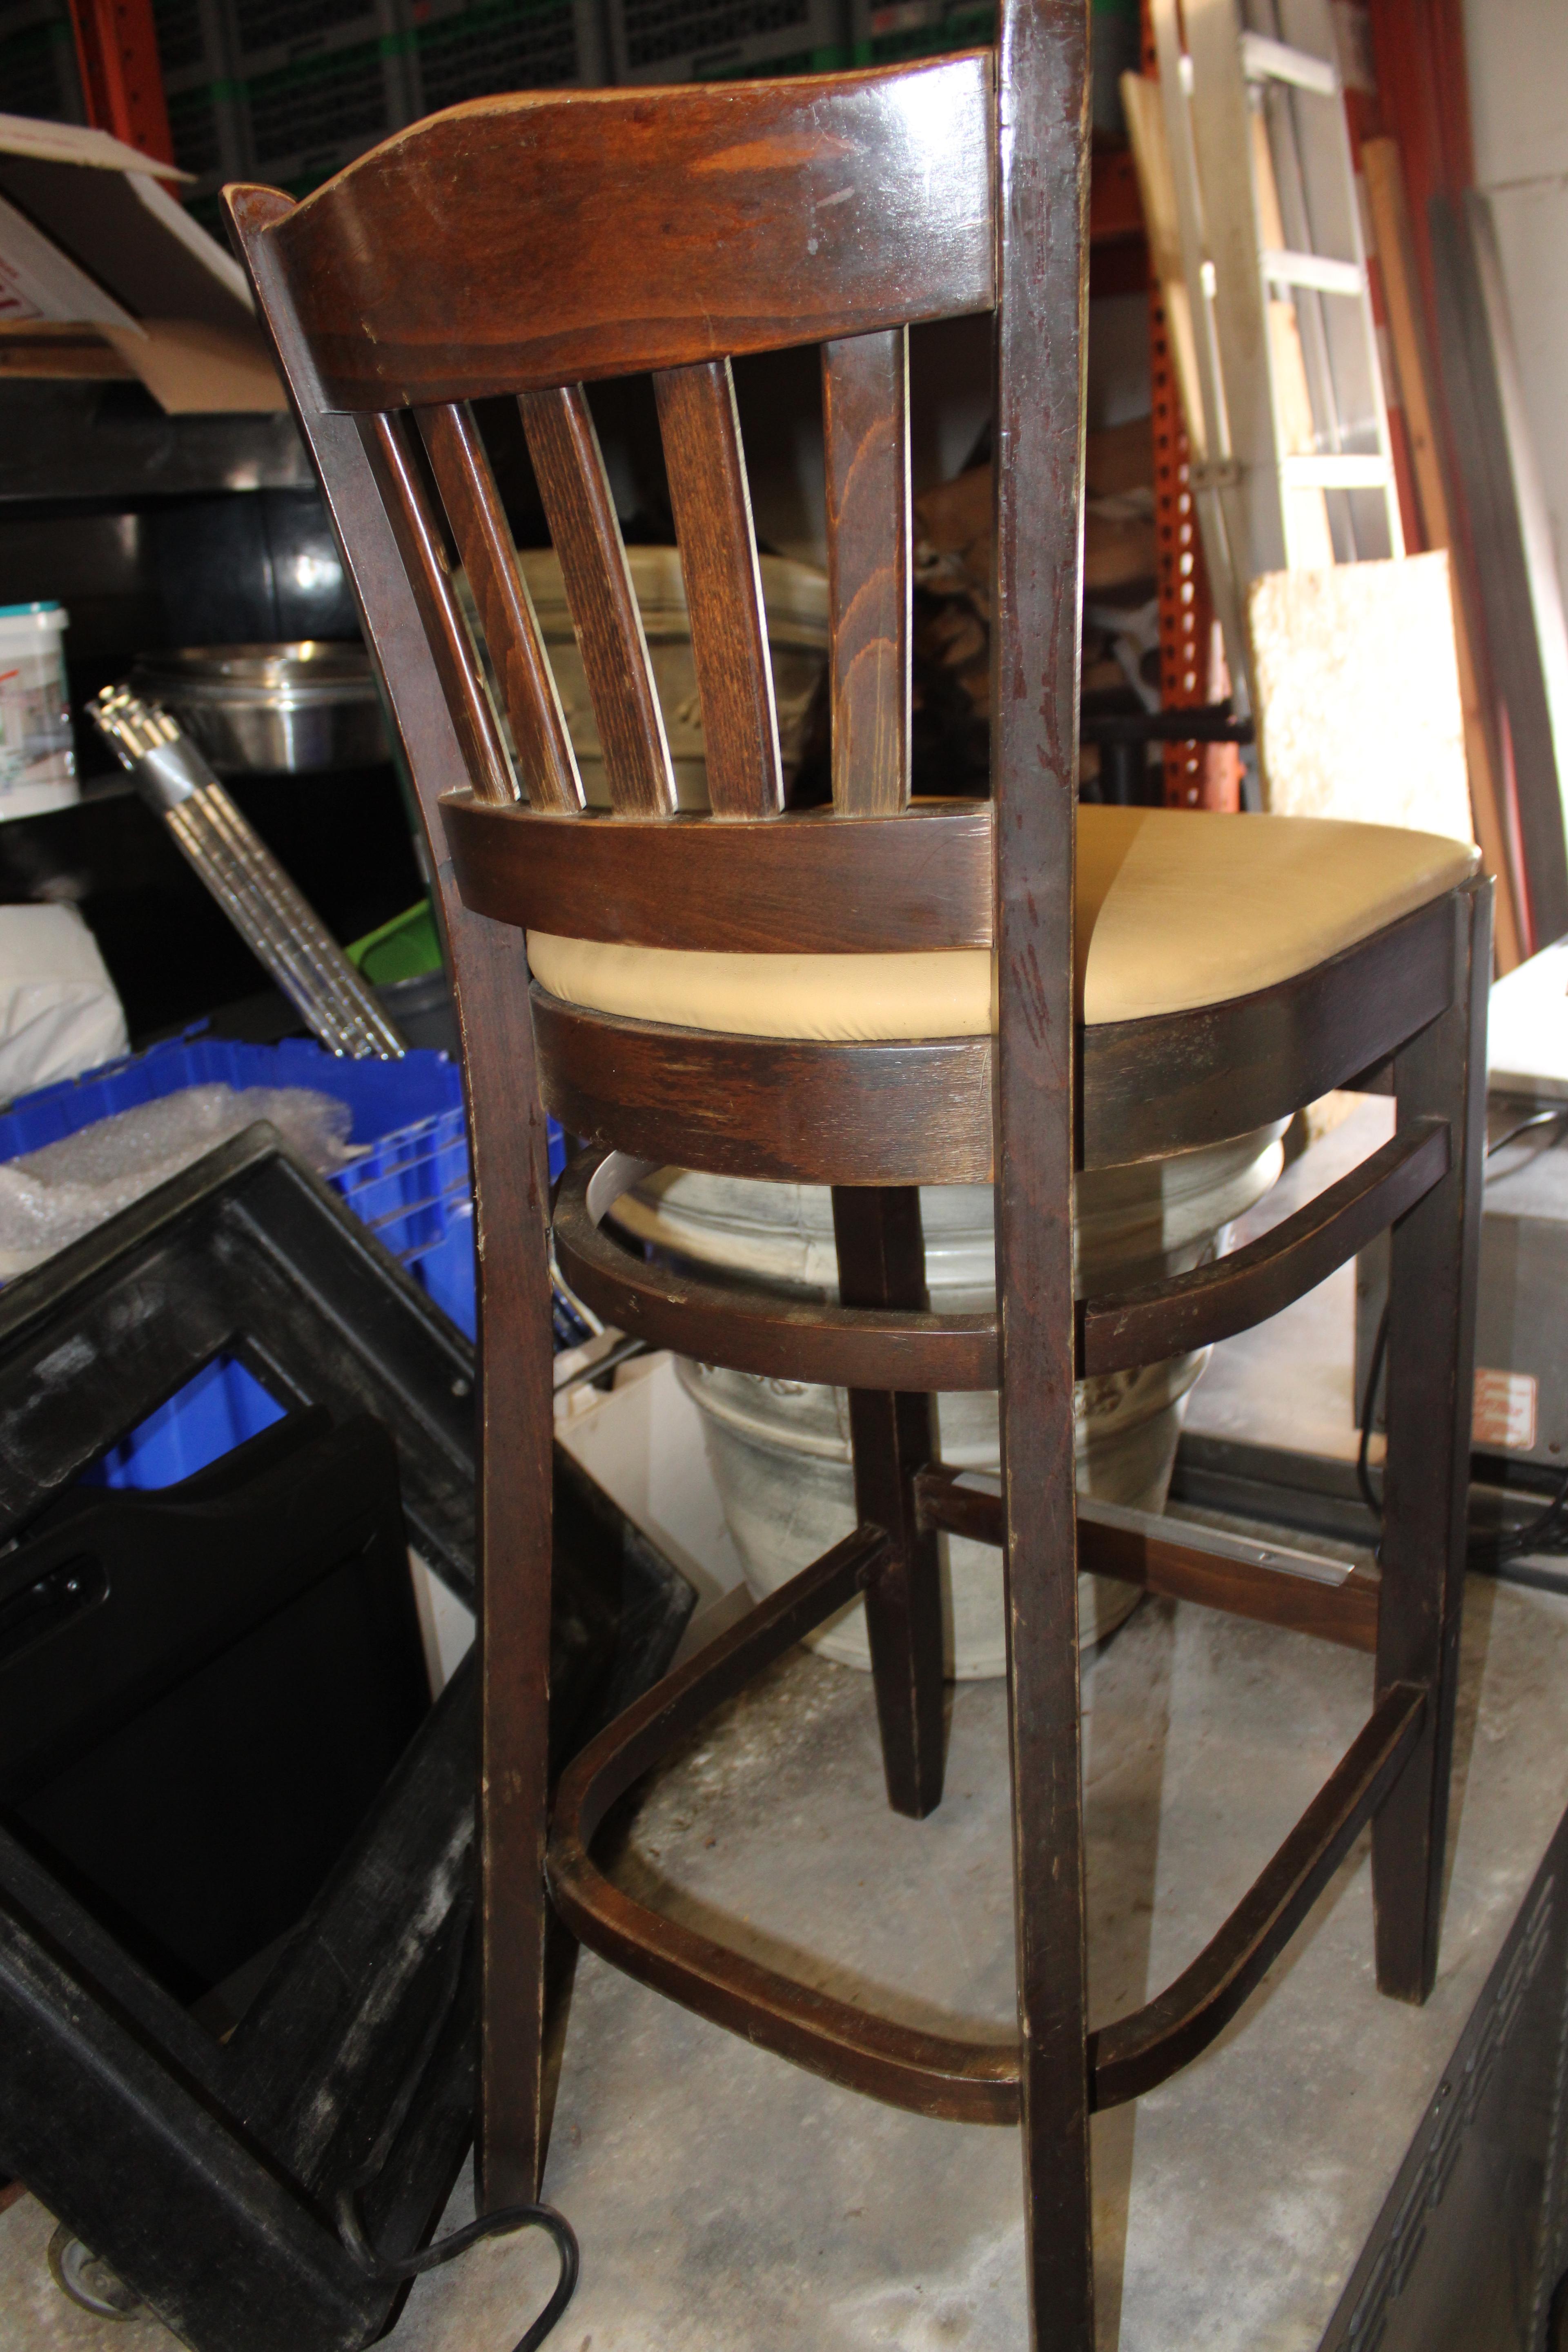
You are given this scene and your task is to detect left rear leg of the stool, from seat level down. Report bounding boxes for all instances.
[454,915,555,2213]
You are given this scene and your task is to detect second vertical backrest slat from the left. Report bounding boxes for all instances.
[419,400,583,811]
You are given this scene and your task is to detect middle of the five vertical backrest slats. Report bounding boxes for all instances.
[517,383,675,816]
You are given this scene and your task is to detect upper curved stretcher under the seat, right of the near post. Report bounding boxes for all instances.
[1079,1120,1450,1376]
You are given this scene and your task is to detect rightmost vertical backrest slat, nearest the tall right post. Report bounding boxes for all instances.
[823,327,910,816]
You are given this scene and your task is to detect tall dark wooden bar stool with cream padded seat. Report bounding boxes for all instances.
[228,0,1488,2352]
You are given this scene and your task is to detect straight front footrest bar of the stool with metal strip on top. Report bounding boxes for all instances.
[915,1463,1378,1649]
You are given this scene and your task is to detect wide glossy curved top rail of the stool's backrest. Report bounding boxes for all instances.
[232,54,994,409]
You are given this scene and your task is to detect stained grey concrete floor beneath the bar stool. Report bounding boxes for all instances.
[0,1105,1568,2352]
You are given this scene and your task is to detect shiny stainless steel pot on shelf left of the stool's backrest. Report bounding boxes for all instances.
[131,637,390,776]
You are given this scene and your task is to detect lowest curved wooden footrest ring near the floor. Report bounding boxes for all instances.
[546,1526,1427,2124]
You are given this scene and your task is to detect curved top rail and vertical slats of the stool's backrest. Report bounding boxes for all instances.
[228,52,1048,875]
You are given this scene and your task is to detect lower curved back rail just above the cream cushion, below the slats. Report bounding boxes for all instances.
[442,793,992,955]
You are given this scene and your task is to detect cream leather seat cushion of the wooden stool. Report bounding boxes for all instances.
[529,809,1479,1042]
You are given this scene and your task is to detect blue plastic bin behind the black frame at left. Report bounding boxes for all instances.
[0,1035,566,1486]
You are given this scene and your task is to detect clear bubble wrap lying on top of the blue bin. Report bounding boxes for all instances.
[0,1084,360,1279]
